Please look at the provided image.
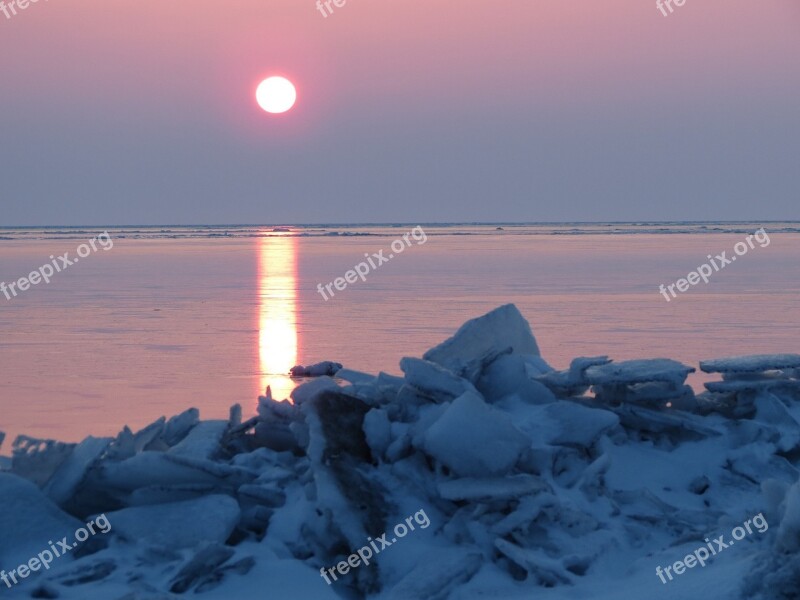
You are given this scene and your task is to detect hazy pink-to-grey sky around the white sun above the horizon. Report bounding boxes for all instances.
[0,0,800,226]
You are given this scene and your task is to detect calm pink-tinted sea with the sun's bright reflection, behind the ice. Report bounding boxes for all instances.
[0,223,800,446]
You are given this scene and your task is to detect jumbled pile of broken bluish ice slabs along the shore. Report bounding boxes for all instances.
[0,305,800,600]
